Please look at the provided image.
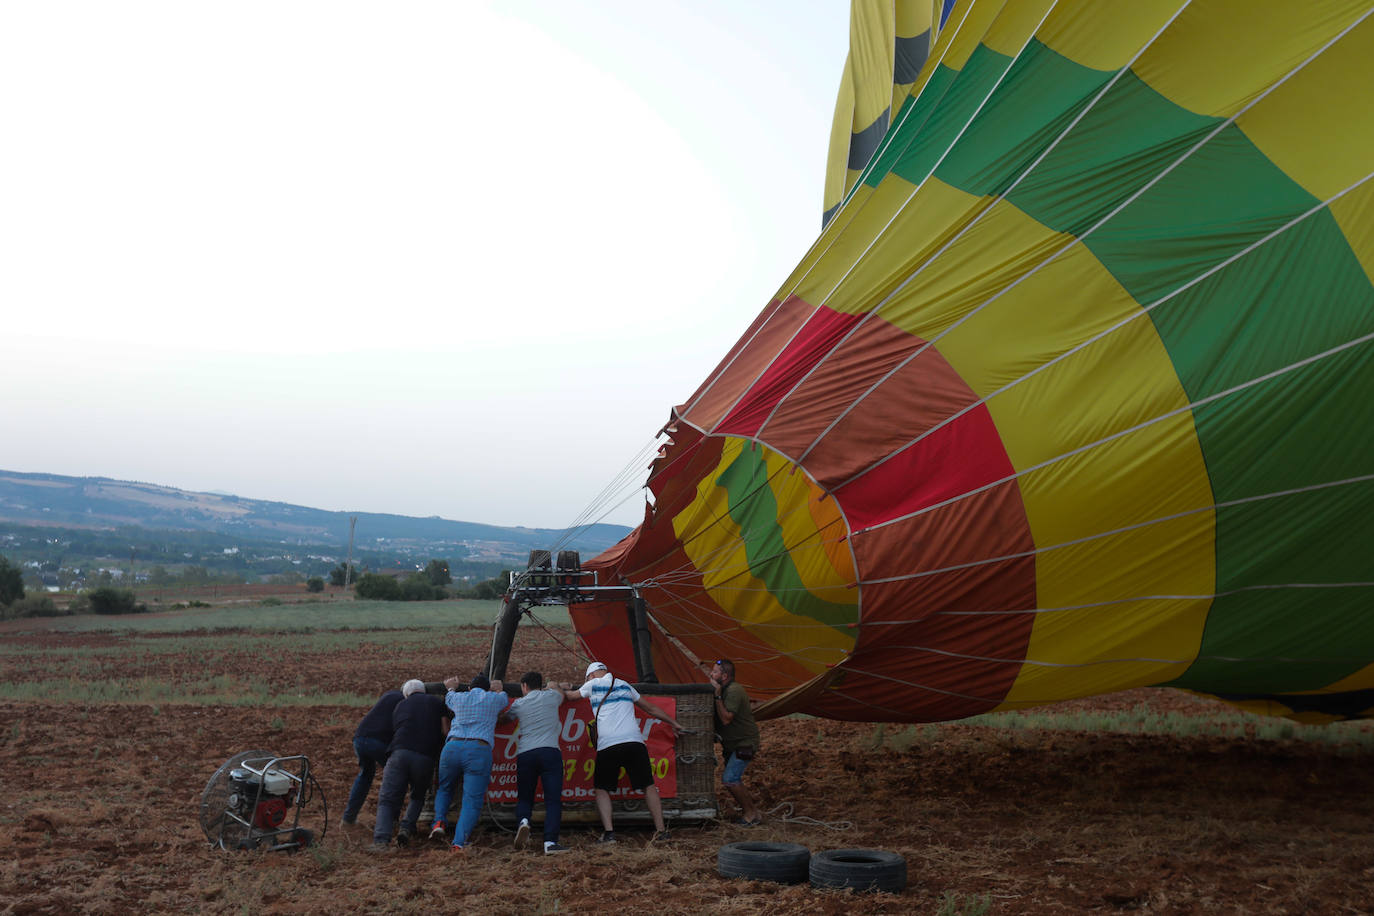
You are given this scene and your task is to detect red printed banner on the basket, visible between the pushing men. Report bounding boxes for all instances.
[486,696,677,803]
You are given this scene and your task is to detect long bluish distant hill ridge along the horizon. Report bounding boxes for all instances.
[0,470,629,563]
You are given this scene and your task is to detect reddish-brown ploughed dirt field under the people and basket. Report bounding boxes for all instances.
[0,622,1374,915]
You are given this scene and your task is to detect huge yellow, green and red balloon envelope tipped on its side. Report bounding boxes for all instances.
[505,0,1374,722]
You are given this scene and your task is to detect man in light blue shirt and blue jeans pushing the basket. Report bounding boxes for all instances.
[430,674,510,853]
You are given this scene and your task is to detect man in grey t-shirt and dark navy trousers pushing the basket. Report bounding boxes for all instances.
[500,672,567,856]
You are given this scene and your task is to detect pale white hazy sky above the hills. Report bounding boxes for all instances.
[0,0,849,527]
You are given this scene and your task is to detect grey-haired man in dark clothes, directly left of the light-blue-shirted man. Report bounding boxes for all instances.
[371,680,452,853]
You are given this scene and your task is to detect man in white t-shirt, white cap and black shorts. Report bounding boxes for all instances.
[563,662,684,843]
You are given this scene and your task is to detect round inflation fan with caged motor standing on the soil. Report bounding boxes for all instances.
[201,751,328,850]
